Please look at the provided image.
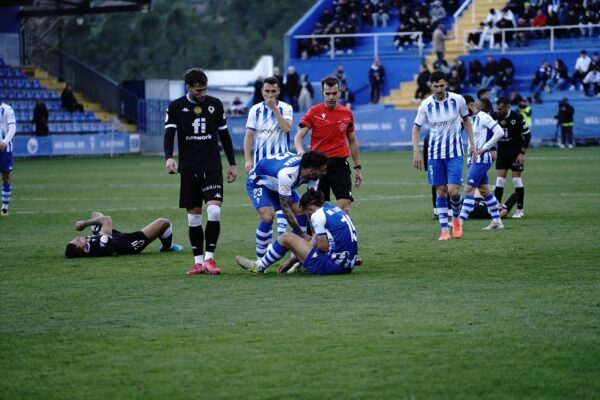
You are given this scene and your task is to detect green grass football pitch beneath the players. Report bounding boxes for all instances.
[0,147,600,399]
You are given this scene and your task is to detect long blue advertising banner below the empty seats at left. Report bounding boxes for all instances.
[13,133,140,157]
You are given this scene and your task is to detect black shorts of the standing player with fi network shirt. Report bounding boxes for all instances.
[179,169,223,208]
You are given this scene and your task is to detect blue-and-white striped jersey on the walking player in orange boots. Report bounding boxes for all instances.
[415,92,469,160]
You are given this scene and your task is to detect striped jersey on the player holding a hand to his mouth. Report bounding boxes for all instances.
[246,101,294,164]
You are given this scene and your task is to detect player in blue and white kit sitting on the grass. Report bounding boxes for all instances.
[236,190,358,275]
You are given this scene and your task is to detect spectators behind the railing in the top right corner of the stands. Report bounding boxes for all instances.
[467,0,600,49]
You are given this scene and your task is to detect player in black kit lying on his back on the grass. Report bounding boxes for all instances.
[65,211,183,258]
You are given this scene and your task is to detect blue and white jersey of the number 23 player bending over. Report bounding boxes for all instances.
[248,153,318,198]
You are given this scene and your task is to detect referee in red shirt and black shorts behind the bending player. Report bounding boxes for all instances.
[294,76,362,215]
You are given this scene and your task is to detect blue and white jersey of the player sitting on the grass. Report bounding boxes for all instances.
[310,203,358,268]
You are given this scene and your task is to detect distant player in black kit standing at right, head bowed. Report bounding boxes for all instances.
[491,97,531,218]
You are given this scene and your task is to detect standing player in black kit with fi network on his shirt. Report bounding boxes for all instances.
[164,68,237,275]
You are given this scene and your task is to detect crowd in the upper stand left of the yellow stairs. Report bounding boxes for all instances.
[298,0,459,59]
